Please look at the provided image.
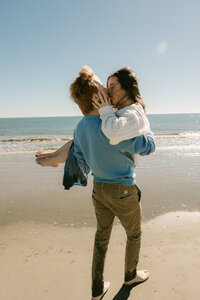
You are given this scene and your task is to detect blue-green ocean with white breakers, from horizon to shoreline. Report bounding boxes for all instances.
[0,113,200,156]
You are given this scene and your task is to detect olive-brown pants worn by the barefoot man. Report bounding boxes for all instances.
[92,182,141,297]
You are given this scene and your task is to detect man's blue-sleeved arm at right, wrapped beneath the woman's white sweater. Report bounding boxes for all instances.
[118,132,156,156]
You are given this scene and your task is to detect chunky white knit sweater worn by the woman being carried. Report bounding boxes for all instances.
[99,103,150,145]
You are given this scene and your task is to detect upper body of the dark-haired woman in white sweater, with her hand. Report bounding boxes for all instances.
[94,67,150,166]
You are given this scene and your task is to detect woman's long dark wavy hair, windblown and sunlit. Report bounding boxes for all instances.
[107,67,145,111]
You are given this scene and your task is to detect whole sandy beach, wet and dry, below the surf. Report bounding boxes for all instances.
[0,153,200,300]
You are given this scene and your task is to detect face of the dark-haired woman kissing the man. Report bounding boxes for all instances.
[108,76,125,107]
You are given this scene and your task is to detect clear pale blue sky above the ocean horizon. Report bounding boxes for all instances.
[0,0,200,117]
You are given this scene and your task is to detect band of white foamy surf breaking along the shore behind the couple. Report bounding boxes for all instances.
[0,131,200,154]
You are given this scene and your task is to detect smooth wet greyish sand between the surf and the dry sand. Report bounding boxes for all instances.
[0,153,200,227]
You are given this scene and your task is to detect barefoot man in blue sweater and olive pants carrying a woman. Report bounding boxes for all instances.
[70,67,155,300]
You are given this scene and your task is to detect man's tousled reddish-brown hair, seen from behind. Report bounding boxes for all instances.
[69,66,98,116]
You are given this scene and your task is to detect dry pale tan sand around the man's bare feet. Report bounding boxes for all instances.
[0,212,200,300]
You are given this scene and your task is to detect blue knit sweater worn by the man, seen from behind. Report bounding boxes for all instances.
[74,116,155,185]
